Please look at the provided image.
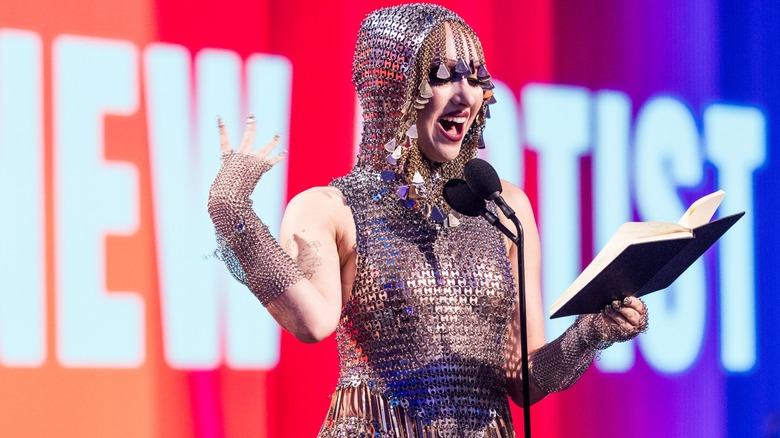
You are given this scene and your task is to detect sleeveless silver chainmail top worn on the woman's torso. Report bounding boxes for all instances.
[320,169,516,437]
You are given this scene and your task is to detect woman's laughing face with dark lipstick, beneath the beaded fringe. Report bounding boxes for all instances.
[417,26,482,163]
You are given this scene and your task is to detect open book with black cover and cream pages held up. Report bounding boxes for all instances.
[550,190,745,318]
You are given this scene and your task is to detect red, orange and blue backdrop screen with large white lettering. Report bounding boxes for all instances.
[0,0,780,438]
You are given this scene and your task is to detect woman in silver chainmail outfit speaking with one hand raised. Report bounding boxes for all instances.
[209,4,647,437]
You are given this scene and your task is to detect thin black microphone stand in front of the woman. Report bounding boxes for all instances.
[482,206,531,438]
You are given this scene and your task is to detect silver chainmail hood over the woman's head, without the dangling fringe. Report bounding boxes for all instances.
[352,3,492,177]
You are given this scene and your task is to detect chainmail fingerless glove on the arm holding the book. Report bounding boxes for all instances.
[529,302,647,394]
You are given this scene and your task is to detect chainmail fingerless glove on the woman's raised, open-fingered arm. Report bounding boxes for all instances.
[208,152,303,306]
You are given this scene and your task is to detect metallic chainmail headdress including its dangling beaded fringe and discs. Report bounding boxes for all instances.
[352,4,495,222]
